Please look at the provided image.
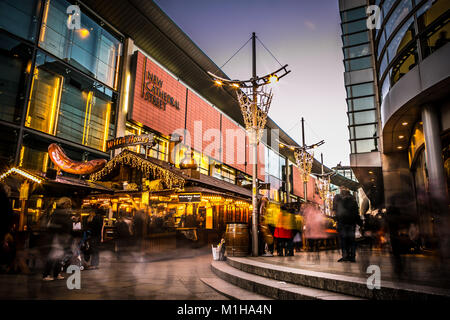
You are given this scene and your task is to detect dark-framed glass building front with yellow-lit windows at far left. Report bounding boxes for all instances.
[0,0,122,172]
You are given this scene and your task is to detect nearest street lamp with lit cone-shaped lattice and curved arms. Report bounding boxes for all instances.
[208,32,291,257]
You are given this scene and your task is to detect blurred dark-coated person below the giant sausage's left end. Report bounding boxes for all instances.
[43,197,72,281]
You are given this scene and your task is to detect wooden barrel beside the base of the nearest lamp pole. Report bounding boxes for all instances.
[225,223,248,257]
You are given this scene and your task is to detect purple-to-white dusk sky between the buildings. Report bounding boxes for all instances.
[156,0,350,167]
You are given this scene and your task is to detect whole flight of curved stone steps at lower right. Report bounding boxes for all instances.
[202,257,450,301]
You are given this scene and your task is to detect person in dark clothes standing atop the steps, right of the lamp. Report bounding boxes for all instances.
[333,187,362,262]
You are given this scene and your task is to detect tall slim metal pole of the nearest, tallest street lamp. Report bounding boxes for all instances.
[251,32,258,257]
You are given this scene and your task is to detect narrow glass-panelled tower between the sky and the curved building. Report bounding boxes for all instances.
[339,0,383,207]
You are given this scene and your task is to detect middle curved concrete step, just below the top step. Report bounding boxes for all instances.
[211,258,361,300]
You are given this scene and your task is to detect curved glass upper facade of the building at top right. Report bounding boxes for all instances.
[375,0,450,100]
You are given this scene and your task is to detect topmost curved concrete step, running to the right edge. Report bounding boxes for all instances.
[226,257,450,300]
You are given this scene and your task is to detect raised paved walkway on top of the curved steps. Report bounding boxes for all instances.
[250,249,450,289]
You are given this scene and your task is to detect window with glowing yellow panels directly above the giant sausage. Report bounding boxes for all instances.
[25,53,115,151]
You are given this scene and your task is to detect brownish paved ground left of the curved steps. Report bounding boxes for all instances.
[0,248,227,300]
